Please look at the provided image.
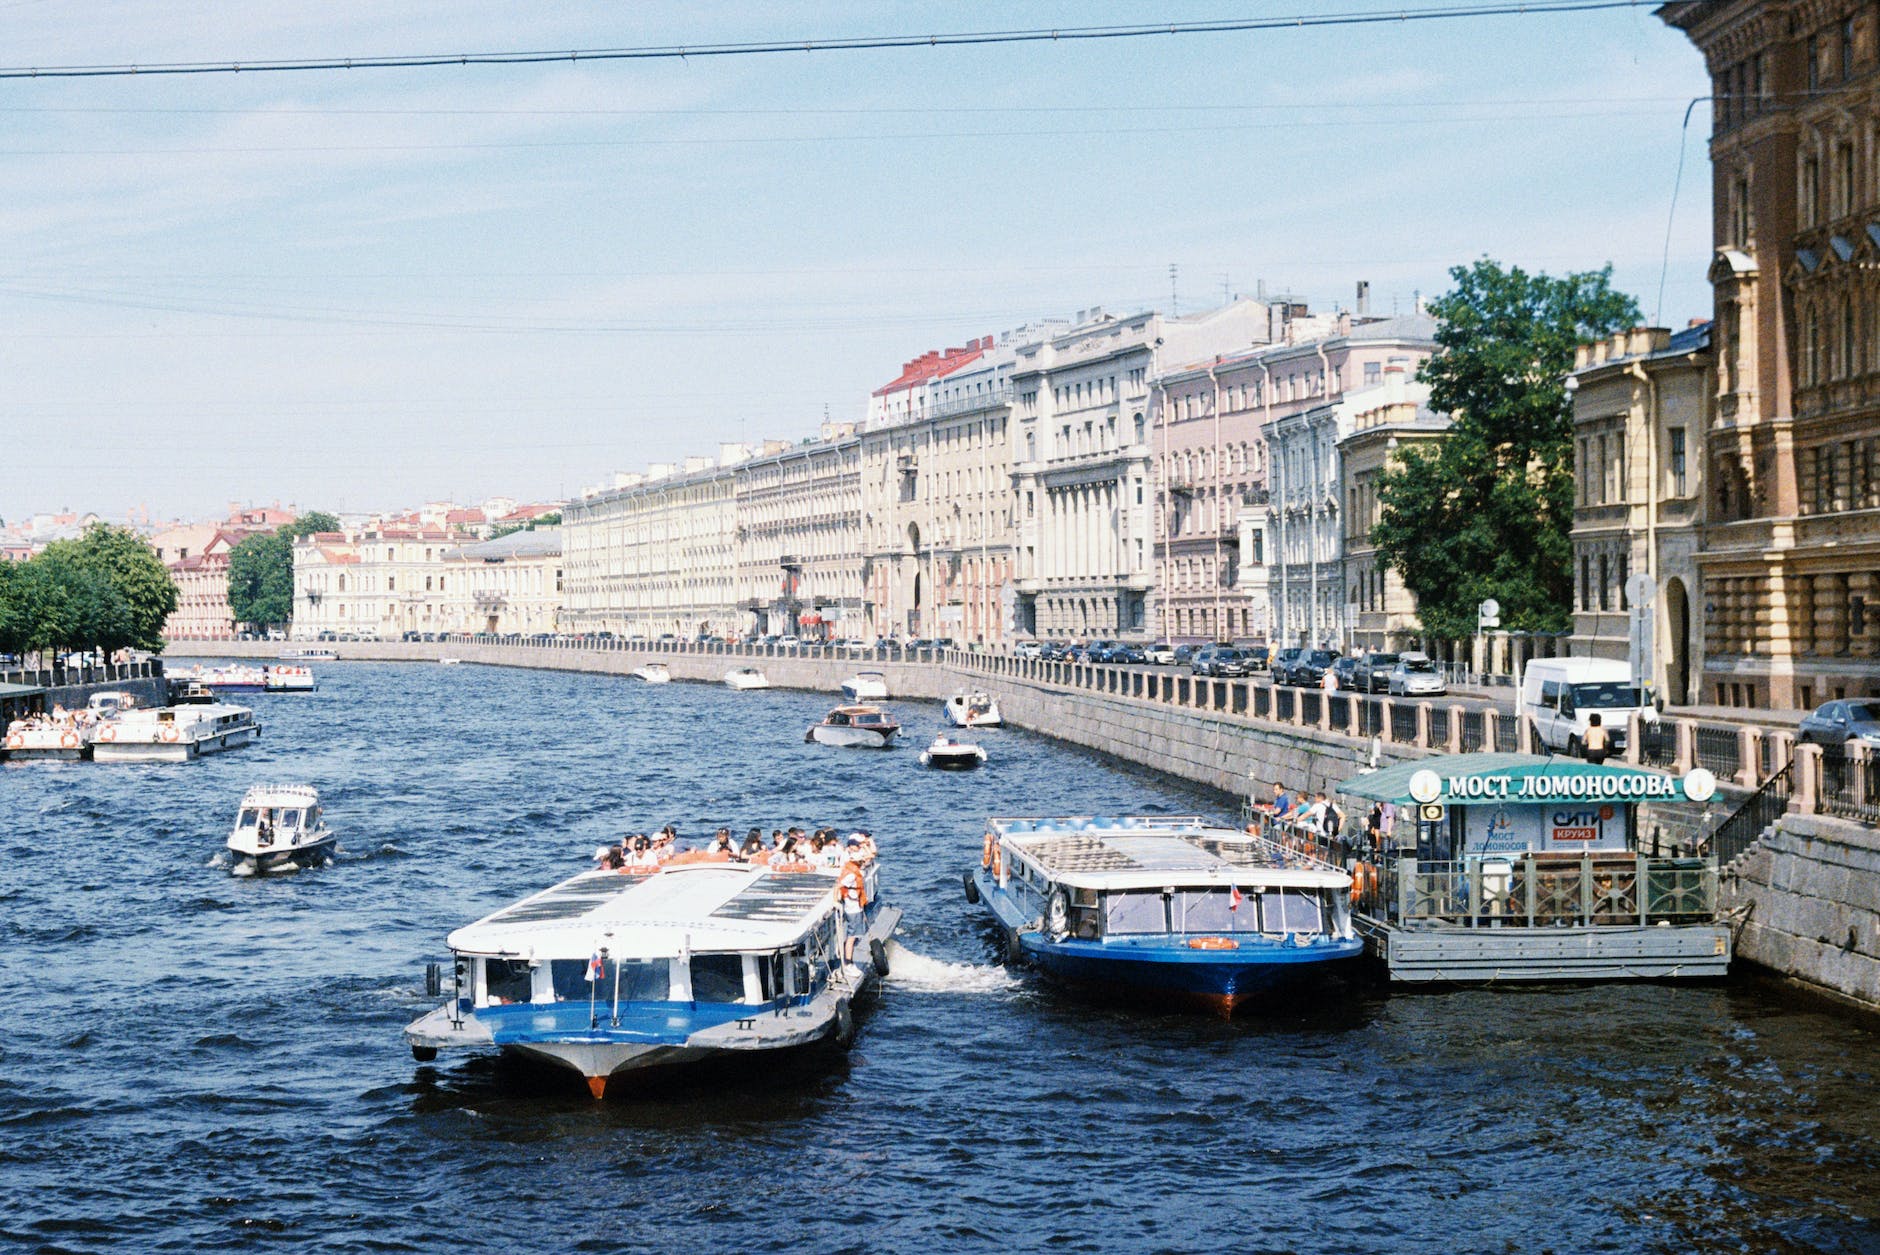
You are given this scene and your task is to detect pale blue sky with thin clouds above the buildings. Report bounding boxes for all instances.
[0,0,1709,519]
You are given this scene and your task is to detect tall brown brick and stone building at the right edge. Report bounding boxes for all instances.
[1658,0,1880,708]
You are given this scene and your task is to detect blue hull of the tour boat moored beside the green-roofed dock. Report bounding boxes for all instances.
[974,868,1365,1015]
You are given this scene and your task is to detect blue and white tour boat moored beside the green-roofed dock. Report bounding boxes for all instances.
[966,815,1365,1013]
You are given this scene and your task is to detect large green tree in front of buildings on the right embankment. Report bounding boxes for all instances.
[1371,257,1639,641]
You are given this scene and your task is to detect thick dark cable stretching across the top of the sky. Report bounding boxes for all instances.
[0,0,1643,79]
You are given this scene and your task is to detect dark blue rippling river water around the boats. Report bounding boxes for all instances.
[0,663,1880,1253]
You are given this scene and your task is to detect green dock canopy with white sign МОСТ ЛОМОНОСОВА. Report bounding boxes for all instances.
[1339,753,1716,806]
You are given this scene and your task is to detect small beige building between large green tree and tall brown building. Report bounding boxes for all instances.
[1570,323,1716,705]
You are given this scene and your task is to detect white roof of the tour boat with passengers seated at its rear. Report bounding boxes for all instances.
[447,862,835,960]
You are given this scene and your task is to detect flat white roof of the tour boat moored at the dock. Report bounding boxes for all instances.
[991,815,1352,889]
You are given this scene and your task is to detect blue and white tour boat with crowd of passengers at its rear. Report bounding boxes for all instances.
[404,855,901,1099]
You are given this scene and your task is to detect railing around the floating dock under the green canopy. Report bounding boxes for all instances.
[1357,849,1716,928]
